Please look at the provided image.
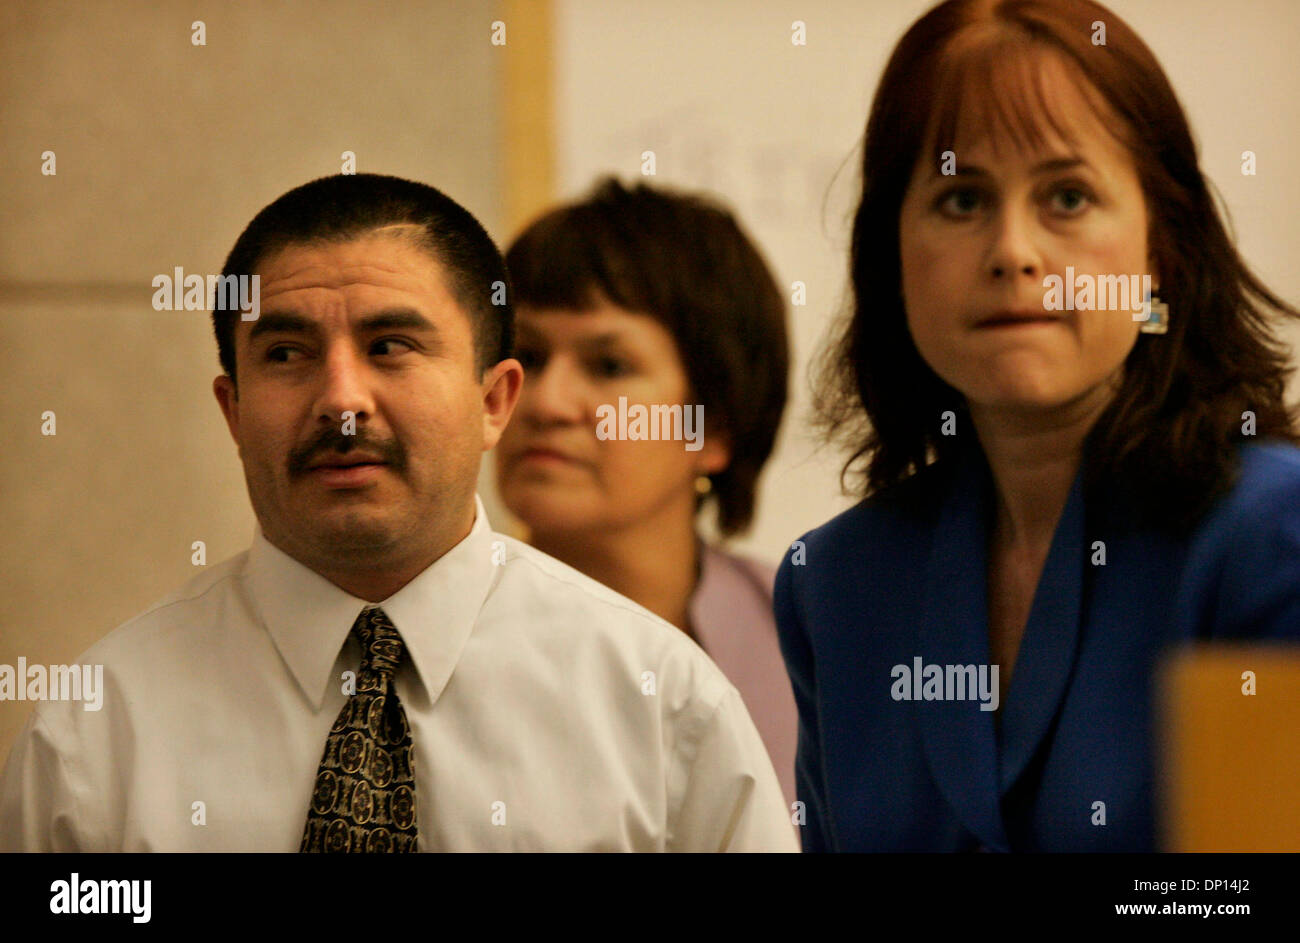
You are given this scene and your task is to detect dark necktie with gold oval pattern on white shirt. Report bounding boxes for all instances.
[299,607,417,852]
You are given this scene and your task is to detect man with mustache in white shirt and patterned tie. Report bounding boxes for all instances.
[0,174,797,852]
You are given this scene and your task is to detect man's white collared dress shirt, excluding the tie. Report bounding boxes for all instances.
[0,502,797,852]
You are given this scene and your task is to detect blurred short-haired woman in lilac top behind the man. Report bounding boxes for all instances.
[497,179,796,801]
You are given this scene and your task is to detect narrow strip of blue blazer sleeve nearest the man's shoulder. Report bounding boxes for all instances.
[772,554,832,852]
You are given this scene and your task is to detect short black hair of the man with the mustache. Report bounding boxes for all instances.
[212,173,515,380]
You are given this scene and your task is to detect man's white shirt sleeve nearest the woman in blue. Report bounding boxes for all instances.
[667,687,798,852]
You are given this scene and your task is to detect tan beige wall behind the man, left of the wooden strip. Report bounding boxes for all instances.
[0,0,502,757]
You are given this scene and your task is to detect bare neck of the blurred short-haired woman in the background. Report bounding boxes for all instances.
[530,496,699,635]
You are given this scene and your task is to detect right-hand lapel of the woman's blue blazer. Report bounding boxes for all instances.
[998,463,1087,795]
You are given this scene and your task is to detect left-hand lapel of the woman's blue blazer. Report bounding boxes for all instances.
[911,450,1009,851]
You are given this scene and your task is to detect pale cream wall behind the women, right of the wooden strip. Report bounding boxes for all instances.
[555,0,1300,561]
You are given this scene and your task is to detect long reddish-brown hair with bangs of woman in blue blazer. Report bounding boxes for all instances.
[816,0,1300,533]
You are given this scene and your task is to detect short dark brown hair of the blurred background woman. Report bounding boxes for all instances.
[506,178,789,536]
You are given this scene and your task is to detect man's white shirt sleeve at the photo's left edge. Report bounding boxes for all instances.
[0,705,82,852]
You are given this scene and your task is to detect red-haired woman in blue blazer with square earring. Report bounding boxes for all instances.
[775,0,1300,851]
